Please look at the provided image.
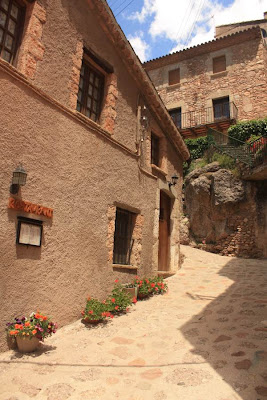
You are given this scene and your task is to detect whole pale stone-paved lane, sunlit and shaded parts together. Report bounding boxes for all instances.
[0,246,267,400]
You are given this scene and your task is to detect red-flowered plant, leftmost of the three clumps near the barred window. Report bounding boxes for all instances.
[81,297,113,324]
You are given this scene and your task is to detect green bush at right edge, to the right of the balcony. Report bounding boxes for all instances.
[228,118,267,145]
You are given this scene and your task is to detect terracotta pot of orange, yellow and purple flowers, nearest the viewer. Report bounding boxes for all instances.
[6,311,57,353]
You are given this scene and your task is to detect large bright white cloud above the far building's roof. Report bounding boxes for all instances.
[131,0,267,51]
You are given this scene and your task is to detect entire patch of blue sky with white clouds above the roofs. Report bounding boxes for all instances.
[107,0,267,61]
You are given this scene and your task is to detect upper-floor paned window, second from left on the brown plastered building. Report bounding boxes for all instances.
[77,59,105,121]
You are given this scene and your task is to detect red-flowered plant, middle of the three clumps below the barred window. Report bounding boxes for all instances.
[106,279,136,314]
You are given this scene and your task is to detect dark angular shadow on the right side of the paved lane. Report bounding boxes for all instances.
[181,259,267,400]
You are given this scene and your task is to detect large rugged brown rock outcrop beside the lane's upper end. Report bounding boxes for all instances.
[184,163,267,257]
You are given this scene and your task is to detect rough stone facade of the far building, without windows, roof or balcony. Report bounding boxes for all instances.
[145,35,267,127]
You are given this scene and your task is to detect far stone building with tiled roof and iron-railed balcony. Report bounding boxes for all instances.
[144,13,267,137]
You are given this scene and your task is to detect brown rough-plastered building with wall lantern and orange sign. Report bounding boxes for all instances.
[0,0,189,349]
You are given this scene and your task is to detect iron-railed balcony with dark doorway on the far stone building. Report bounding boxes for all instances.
[178,101,238,139]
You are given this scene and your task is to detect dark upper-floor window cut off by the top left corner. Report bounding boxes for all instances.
[0,0,24,63]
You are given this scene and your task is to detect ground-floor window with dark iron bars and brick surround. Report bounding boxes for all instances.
[113,208,135,265]
